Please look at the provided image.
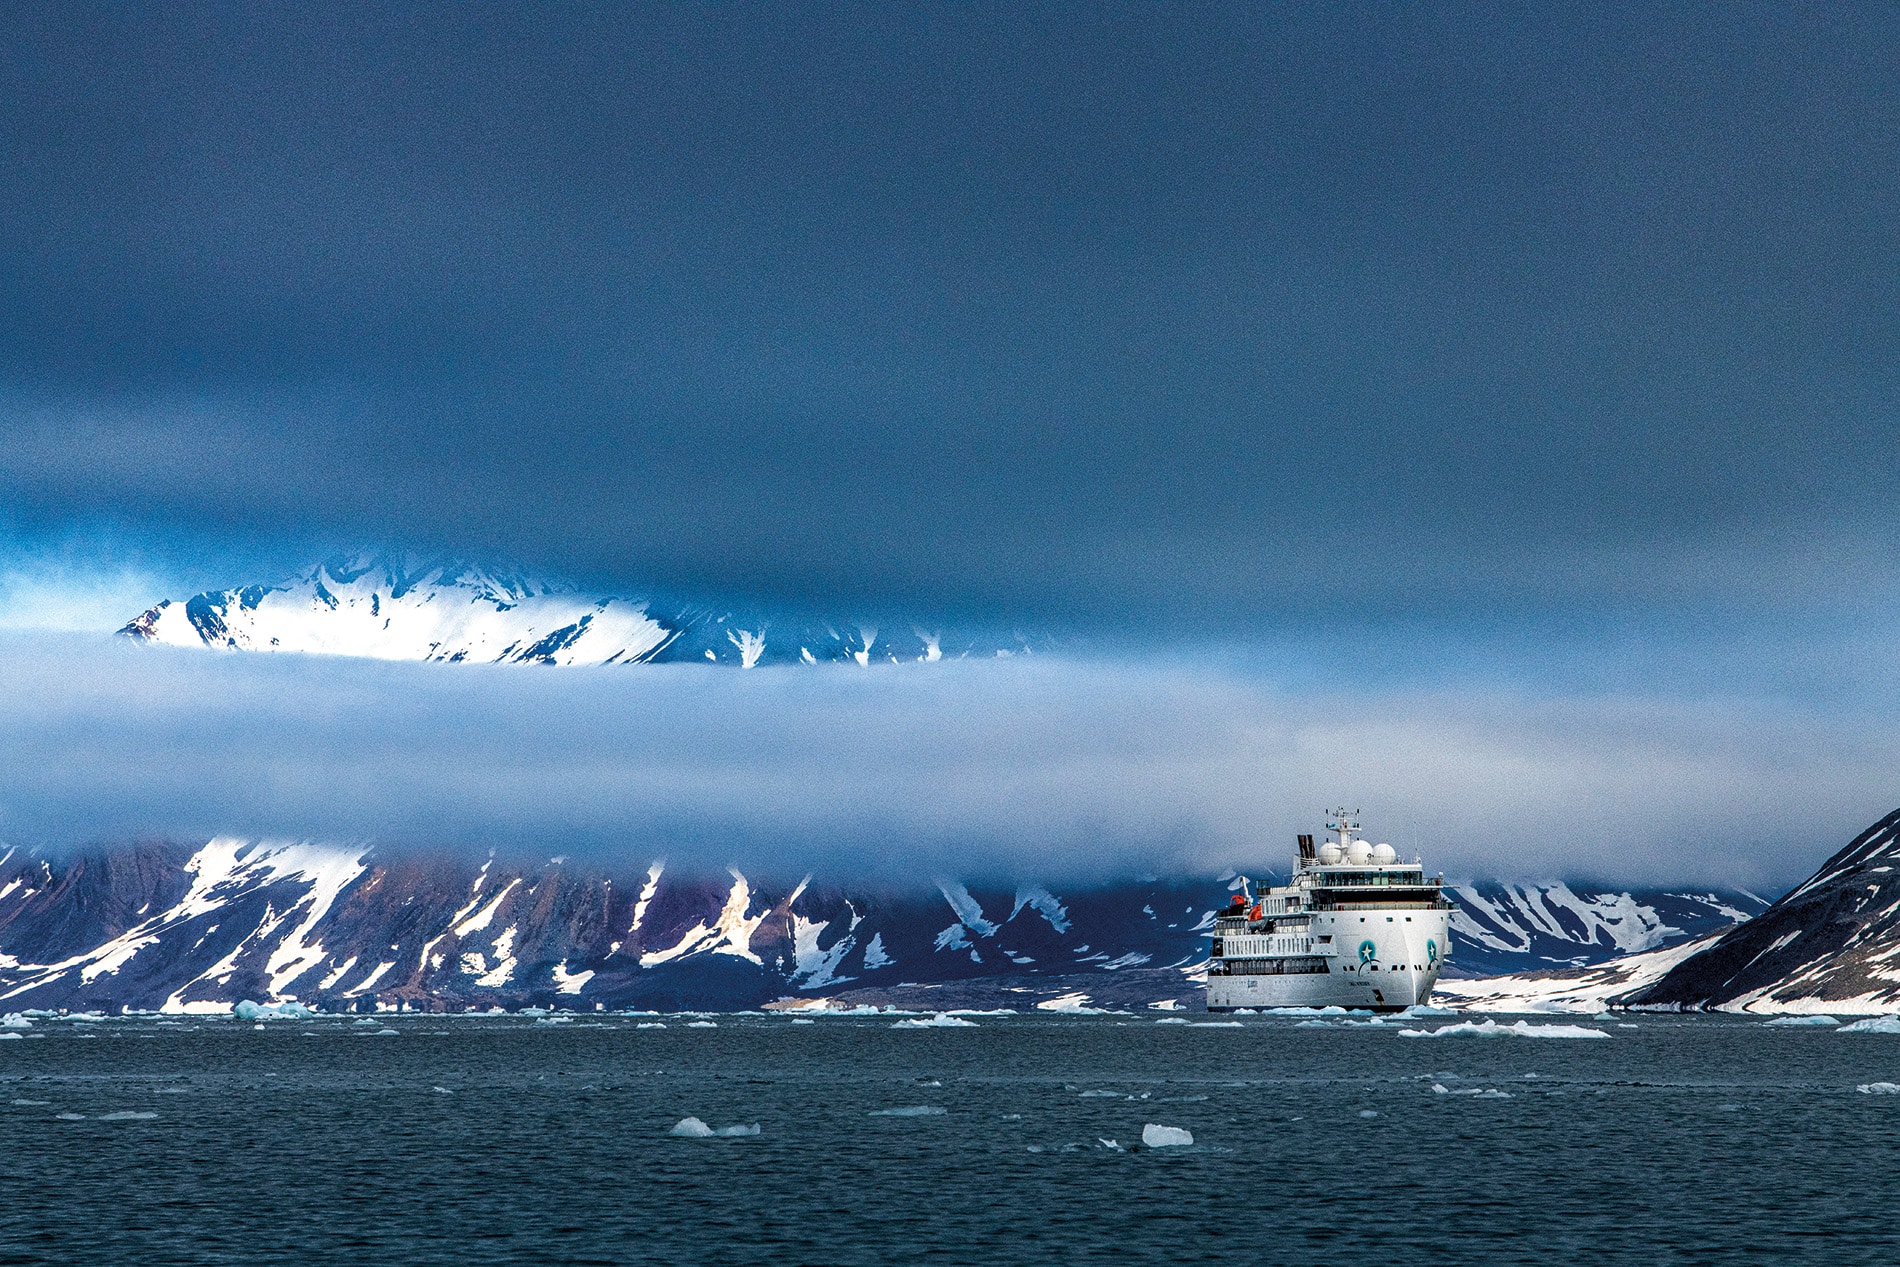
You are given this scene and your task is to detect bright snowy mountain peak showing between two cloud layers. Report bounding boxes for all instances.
[120,555,1032,669]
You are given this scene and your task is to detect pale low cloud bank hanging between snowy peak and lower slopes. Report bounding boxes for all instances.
[0,633,1900,889]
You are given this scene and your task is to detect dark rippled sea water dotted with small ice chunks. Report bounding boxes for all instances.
[0,1016,1900,1267]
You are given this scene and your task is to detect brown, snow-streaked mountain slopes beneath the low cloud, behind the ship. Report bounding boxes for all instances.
[0,838,1740,1011]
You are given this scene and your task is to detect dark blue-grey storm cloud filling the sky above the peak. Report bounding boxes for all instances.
[0,6,1900,623]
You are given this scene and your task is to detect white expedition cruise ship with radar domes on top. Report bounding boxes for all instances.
[1207,809,1454,1012]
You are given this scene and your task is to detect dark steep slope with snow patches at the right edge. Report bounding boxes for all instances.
[1621,809,1900,1012]
